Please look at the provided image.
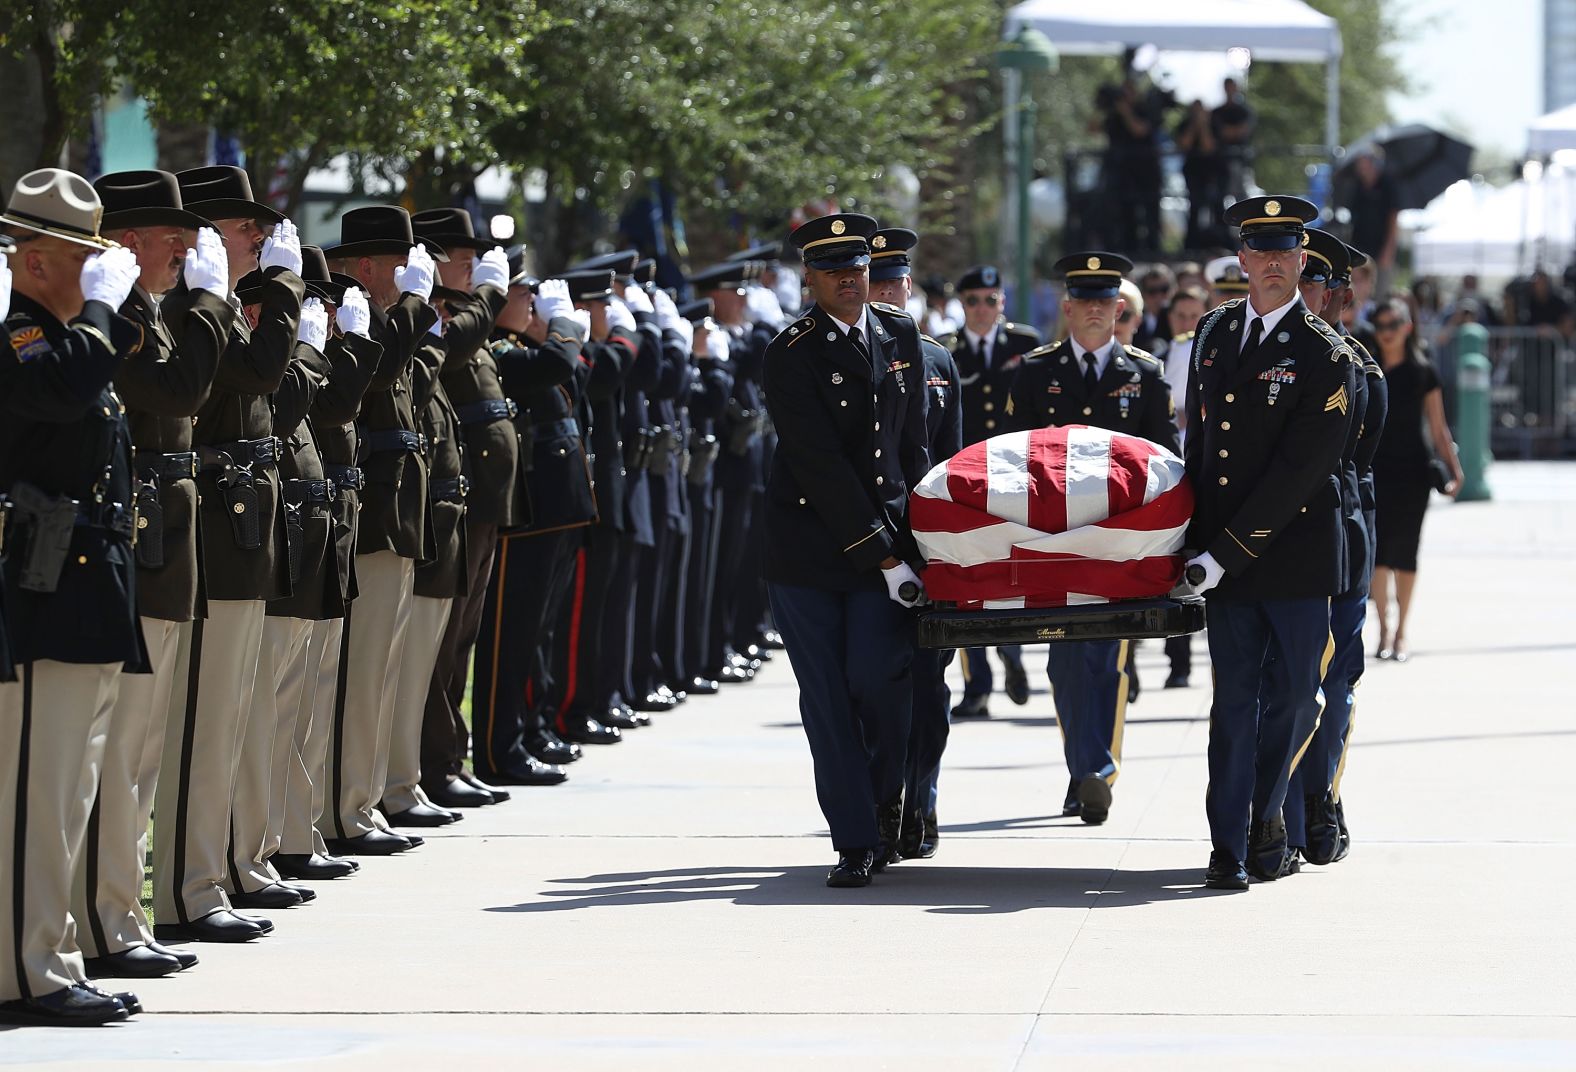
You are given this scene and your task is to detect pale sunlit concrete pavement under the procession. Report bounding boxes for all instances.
[12,465,1576,1072]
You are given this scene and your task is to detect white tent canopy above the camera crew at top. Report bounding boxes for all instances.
[1002,0,1341,147]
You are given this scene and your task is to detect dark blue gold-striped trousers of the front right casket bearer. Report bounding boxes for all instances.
[1204,596,1330,861]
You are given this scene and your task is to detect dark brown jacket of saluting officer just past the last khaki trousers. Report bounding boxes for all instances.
[441,287,520,527]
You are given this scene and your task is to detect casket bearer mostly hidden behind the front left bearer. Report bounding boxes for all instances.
[870,227,963,859]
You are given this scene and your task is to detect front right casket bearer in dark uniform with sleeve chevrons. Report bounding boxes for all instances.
[1187,197,1359,889]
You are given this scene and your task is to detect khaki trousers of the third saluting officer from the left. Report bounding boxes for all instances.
[153,599,266,924]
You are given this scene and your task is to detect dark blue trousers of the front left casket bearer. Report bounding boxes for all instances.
[768,583,914,851]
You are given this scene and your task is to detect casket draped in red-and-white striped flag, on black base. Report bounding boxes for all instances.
[909,424,1204,648]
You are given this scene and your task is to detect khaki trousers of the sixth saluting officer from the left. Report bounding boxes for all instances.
[318,550,416,837]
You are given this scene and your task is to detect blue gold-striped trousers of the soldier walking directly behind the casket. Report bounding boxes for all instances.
[1045,640,1127,782]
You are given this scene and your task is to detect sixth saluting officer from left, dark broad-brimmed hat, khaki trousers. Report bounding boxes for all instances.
[320,205,446,856]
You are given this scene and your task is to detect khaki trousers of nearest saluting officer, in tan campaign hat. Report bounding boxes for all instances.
[0,659,120,1001]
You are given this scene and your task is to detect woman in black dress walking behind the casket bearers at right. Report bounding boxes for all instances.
[1373,298,1461,662]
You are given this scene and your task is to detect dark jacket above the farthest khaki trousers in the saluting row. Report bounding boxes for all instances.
[411,337,474,599]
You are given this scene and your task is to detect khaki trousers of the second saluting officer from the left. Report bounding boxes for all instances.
[71,618,192,957]
